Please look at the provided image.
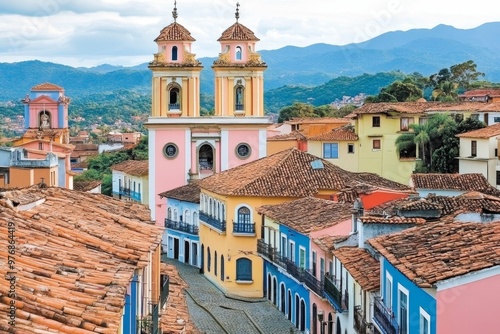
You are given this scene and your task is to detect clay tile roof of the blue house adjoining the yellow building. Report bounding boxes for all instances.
[257,197,352,234]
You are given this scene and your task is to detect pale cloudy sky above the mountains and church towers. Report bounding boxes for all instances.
[0,0,498,67]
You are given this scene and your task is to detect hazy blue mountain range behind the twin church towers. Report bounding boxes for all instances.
[0,22,500,102]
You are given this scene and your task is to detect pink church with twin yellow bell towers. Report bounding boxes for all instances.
[145,3,270,223]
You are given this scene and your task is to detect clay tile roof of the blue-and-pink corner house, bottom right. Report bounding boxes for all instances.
[368,222,500,287]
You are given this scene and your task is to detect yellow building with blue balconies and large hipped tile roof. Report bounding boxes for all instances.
[195,148,410,298]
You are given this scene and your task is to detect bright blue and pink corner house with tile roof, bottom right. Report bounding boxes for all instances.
[368,222,500,334]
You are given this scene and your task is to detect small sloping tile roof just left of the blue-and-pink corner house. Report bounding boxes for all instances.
[332,247,380,291]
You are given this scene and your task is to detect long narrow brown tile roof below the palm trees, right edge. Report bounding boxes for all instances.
[411,173,500,196]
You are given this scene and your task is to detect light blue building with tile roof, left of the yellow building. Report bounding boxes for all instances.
[159,182,201,267]
